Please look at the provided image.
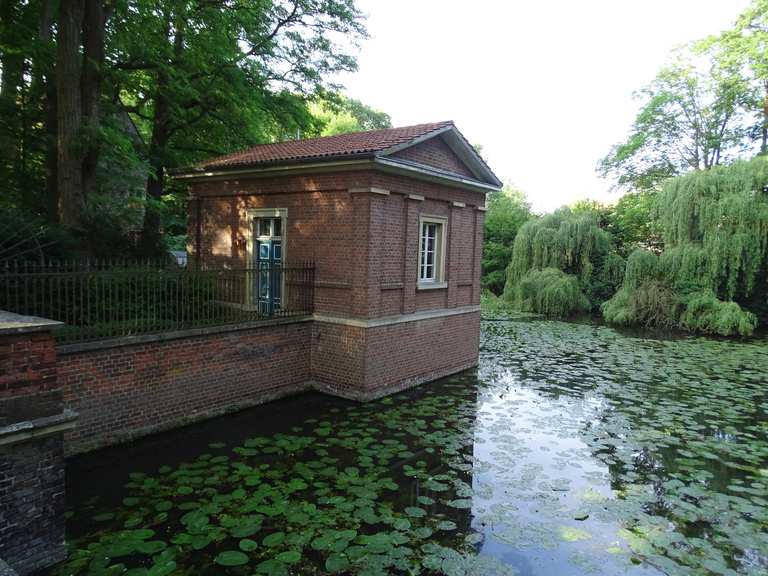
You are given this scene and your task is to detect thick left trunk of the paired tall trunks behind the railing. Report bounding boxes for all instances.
[56,0,85,226]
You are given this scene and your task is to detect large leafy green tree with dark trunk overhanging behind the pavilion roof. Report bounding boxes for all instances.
[108,0,365,253]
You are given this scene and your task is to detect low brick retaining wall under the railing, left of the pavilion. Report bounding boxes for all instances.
[58,322,311,454]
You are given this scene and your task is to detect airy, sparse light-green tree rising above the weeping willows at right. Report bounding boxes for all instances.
[598,49,756,190]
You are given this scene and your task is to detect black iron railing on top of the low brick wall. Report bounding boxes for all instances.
[0,261,314,343]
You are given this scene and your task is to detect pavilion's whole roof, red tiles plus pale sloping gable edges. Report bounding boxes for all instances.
[179,120,501,187]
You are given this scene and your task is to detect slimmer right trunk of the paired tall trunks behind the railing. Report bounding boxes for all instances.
[81,0,112,202]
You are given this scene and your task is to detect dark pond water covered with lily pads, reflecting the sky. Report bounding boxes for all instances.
[49,320,768,576]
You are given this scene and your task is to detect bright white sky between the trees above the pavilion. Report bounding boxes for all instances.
[340,0,749,211]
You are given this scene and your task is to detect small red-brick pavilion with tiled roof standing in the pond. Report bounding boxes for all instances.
[175,122,501,400]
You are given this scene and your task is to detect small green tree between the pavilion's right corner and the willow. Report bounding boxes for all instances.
[481,184,533,295]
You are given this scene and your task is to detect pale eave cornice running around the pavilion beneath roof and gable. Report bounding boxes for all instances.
[171,155,501,193]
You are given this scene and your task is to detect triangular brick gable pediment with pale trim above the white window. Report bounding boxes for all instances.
[378,125,501,186]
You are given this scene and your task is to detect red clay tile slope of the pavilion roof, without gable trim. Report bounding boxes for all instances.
[198,121,453,168]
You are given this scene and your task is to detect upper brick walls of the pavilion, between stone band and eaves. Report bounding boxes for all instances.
[189,171,485,318]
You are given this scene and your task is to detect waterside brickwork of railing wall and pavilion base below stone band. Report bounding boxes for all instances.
[58,311,479,455]
